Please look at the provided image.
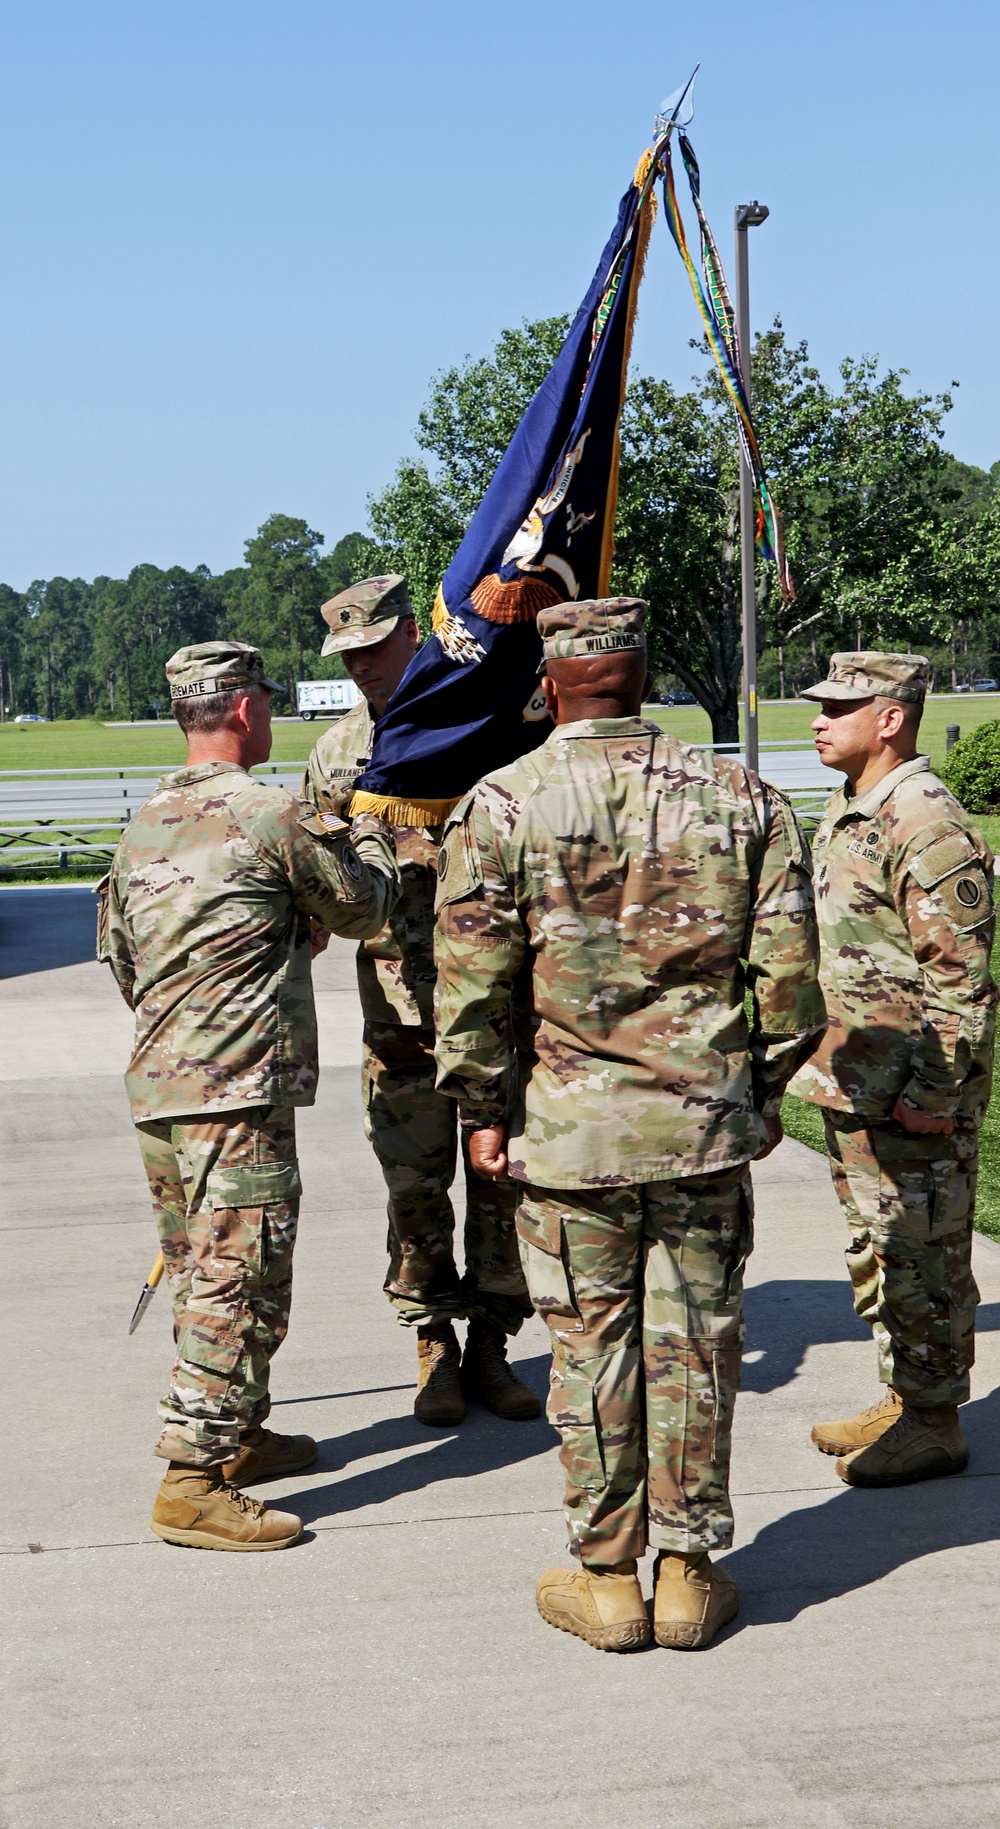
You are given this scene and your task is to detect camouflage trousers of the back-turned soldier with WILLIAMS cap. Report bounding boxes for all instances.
[517,1163,753,1567]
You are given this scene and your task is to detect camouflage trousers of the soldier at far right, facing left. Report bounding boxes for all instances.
[823,1110,980,1408]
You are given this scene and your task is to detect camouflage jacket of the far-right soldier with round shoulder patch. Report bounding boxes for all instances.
[792,755,996,1127]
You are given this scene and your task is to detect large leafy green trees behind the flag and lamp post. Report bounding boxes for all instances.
[369,318,1000,741]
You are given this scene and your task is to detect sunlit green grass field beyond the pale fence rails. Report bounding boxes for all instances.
[0,693,1000,770]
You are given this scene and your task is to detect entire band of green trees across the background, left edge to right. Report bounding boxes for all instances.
[0,316,1000,741]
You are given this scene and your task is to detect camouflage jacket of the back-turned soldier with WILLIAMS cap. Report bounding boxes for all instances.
[435,719,824,1189]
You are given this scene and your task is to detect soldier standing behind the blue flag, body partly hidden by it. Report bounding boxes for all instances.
[302,574,541,1427]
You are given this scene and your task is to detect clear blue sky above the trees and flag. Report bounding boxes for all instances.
[0,0,1000,589]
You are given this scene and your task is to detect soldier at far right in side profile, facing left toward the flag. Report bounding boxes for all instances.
[792,653,996,1487]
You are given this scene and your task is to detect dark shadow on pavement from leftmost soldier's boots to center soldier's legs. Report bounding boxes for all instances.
[274,1353,559,1524]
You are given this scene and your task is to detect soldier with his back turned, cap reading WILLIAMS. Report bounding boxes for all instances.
[435,598,824,1650]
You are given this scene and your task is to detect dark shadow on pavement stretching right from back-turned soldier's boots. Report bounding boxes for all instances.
[726,1386,1000,1630]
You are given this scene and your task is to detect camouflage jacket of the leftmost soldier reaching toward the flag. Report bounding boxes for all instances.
[99,763,399,1123]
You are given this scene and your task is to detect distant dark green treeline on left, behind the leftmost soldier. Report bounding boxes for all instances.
[0,514,371,719]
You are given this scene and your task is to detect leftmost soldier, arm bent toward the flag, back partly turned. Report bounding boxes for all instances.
[99,642,399,1549]
